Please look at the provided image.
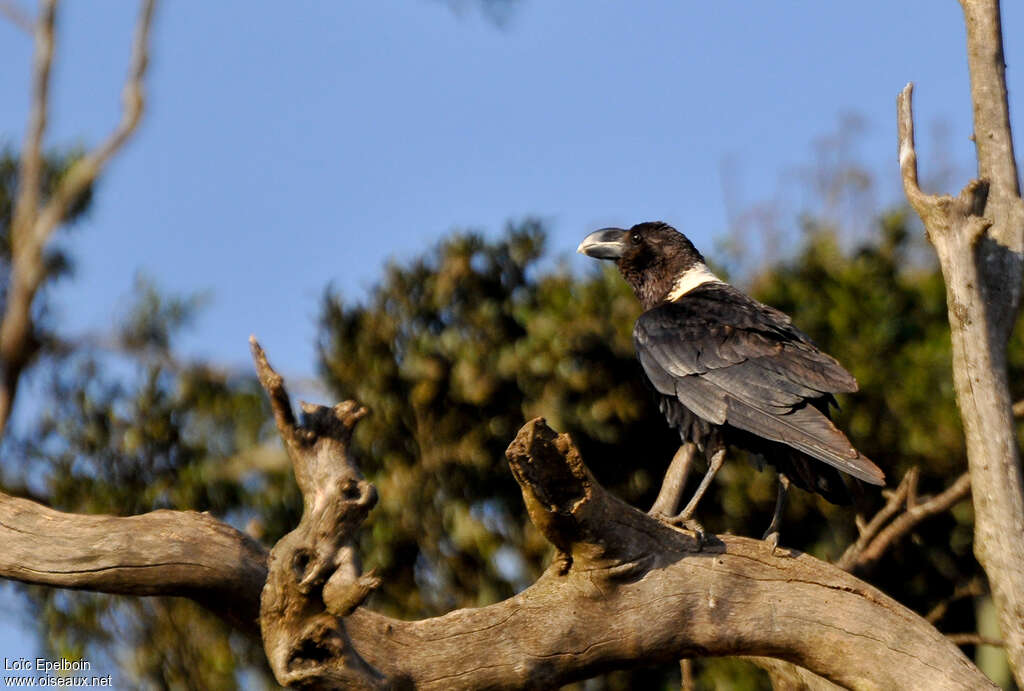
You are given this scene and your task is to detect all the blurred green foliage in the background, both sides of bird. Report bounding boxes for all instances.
[5,171,1007,689]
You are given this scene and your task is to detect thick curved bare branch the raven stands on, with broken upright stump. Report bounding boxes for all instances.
[345,420,990,689]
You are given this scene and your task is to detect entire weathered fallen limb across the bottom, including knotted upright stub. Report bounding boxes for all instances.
[0,346,990,689]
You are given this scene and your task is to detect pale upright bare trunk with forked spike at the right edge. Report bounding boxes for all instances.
[899,0,1024,686]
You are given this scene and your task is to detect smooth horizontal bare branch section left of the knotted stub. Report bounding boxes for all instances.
[0,494,267,634]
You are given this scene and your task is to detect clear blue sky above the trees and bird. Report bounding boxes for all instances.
[0,0,1024,679]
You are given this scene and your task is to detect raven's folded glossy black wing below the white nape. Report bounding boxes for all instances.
[633,284,884,484]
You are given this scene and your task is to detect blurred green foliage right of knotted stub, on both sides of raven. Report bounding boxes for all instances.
[321,211,1003,688]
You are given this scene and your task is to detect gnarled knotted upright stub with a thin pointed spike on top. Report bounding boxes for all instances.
[250,339,387,689]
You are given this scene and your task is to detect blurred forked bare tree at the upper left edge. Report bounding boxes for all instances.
[0,0,156,436]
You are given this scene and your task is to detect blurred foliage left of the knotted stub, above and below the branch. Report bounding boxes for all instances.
[8,279,280,689]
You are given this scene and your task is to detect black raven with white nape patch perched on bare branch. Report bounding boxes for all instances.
[578,222,885,542]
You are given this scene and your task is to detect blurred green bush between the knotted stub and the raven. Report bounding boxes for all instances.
[321,220,675,616]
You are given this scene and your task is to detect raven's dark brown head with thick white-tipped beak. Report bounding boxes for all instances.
[577,221,714,309]
